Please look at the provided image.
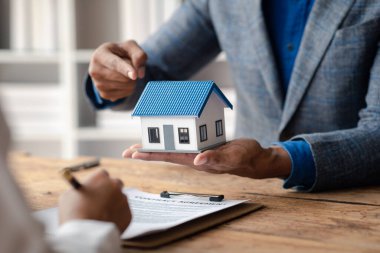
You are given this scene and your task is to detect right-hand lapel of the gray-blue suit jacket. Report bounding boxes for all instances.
[279,0,354,132]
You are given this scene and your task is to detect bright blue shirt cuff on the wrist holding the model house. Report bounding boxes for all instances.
[275,140,316,191]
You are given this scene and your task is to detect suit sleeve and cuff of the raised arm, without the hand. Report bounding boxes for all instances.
[86,0,221,110]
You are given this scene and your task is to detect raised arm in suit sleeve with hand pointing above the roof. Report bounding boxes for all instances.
[86,0,221,110]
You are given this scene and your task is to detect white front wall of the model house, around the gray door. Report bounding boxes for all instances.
[141,117,198,151]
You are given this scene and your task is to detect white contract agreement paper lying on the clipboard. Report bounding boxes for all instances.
[121,189,246,239]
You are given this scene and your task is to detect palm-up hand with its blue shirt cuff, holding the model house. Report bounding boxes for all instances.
[123,139,316,191]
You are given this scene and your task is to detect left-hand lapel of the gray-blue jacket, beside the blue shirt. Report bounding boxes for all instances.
[248,0,284,113]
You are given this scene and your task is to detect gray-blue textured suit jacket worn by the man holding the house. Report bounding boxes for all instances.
[115,0,380,191]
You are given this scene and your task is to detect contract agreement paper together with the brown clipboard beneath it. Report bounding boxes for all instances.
[34,188,261,247]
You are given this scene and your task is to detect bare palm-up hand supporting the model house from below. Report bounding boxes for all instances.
[123,139,291,179]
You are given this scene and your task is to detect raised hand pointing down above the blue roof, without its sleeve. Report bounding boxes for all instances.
[88,40,147,101]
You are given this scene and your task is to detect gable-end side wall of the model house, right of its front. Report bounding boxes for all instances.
[196,93,226,149]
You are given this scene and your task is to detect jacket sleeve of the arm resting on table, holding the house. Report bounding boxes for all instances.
[293,49,380,191]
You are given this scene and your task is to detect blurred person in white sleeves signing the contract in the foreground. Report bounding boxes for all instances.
[0,108,131,253]
